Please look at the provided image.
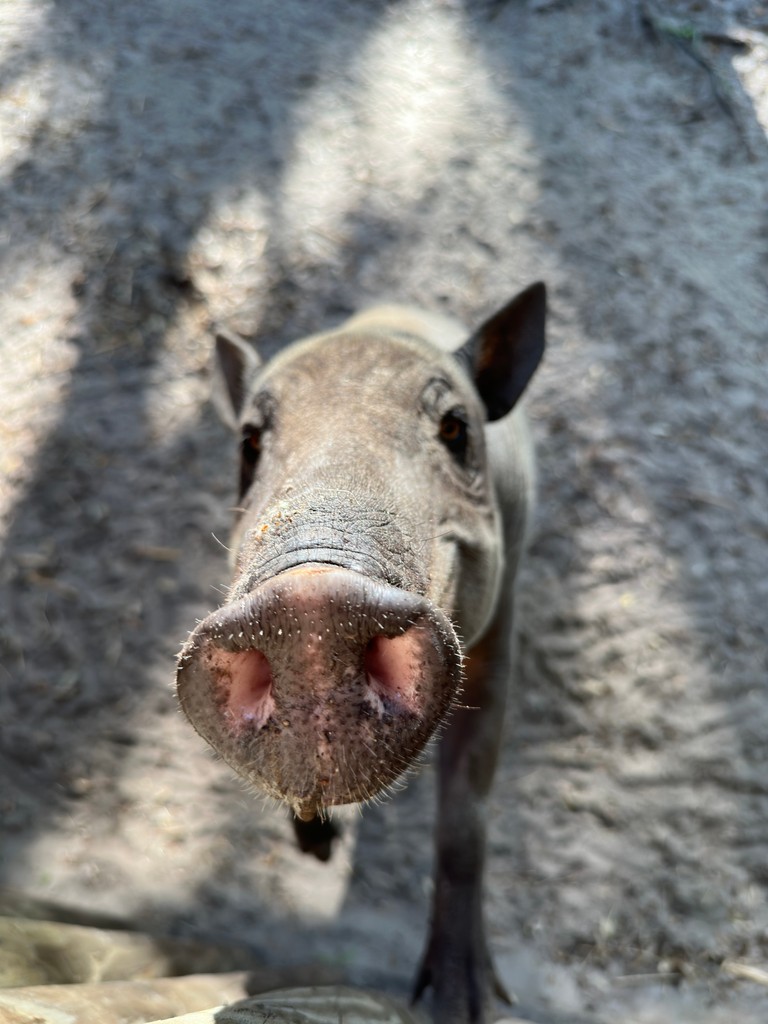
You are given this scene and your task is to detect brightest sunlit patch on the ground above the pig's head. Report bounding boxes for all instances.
[281,2,537,260]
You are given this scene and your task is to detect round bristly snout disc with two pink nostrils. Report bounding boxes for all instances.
[177,565,461,818]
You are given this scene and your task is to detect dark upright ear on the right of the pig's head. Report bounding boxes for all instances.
[455,281,547,420]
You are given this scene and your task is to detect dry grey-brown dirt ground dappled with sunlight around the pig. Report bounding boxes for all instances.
[0,0,768,1024]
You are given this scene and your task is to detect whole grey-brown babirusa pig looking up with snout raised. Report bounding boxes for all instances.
[177,285,545,1022]
